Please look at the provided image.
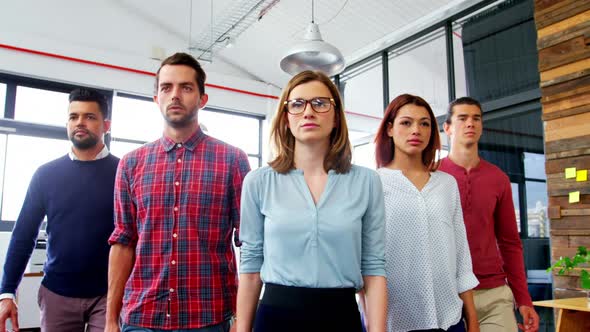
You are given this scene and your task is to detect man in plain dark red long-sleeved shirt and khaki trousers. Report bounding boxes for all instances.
[439,97,539,332]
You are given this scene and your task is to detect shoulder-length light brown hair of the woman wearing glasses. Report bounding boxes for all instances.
[268,70,352,174]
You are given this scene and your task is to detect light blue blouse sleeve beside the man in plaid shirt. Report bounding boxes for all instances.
[240,171,264,273]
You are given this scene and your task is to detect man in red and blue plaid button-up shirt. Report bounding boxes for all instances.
[105,53,250,332]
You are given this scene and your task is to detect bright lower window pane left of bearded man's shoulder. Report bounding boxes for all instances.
[2,135,70,221]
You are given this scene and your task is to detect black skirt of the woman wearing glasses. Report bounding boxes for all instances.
[254,284,363,332]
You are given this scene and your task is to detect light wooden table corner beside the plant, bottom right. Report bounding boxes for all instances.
[533,297,590,332]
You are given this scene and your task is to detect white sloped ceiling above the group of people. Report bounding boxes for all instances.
[0,0,488,87]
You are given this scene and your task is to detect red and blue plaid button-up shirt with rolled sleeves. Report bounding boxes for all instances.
[109,130,250,329]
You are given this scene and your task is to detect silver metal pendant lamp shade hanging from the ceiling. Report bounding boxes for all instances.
[280,23,345,76]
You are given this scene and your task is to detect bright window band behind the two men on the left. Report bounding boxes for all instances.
[0,80,264,226]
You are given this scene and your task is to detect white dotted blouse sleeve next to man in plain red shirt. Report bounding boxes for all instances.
[451,181,479,293]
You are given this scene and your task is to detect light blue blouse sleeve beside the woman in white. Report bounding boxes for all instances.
[361,172,385,276]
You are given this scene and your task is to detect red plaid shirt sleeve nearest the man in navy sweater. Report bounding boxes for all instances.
[109,157,137,246]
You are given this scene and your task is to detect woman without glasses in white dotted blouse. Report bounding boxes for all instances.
[375,94,485,332]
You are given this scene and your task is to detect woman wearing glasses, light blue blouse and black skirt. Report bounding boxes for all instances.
[237,71,387,332]
